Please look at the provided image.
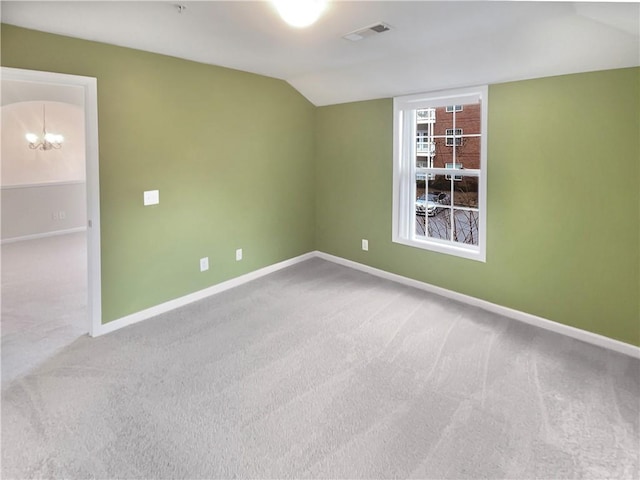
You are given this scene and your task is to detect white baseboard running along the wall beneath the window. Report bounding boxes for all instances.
[315,252,640,358]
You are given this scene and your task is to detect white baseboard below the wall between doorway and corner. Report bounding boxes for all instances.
[93,252,316,337]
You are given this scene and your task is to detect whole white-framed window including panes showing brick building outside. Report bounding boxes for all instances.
[392,86,488,262]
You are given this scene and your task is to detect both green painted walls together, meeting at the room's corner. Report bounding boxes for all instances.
[1,25,640,345]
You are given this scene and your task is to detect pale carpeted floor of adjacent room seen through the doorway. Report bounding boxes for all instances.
[1,232,88,388]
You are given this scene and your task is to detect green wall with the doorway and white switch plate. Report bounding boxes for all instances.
[2,25,315,322]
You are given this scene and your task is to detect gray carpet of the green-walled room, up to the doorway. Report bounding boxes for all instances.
[2,259,640,479]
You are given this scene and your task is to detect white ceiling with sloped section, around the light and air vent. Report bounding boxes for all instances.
[1,0,640,105]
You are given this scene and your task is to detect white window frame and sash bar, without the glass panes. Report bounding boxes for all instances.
[392,85,489,262]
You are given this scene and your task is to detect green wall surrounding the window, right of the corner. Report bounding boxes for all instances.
[316,68,640,345]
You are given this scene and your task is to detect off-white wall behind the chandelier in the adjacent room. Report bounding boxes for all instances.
[0,96,87,241]
